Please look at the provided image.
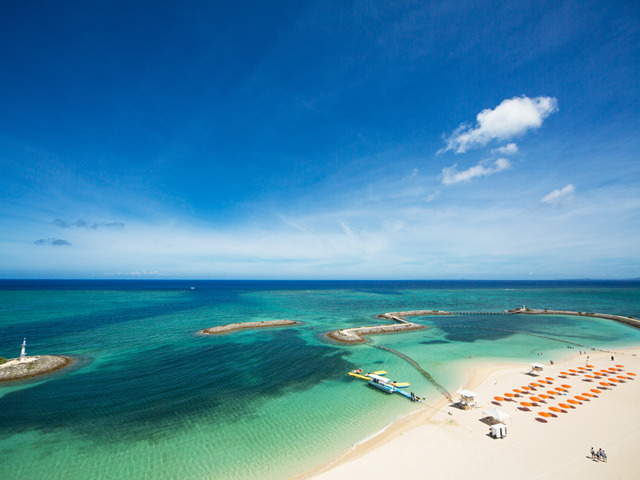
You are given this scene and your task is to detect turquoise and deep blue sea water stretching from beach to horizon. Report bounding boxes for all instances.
[0,281,640,480]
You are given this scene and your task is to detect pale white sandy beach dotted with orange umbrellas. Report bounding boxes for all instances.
[309,349,640,480]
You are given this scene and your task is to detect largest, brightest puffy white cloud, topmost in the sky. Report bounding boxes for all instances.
[439,95,558,153]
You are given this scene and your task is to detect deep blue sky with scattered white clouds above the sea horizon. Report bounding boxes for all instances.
[0,0,640,279]
